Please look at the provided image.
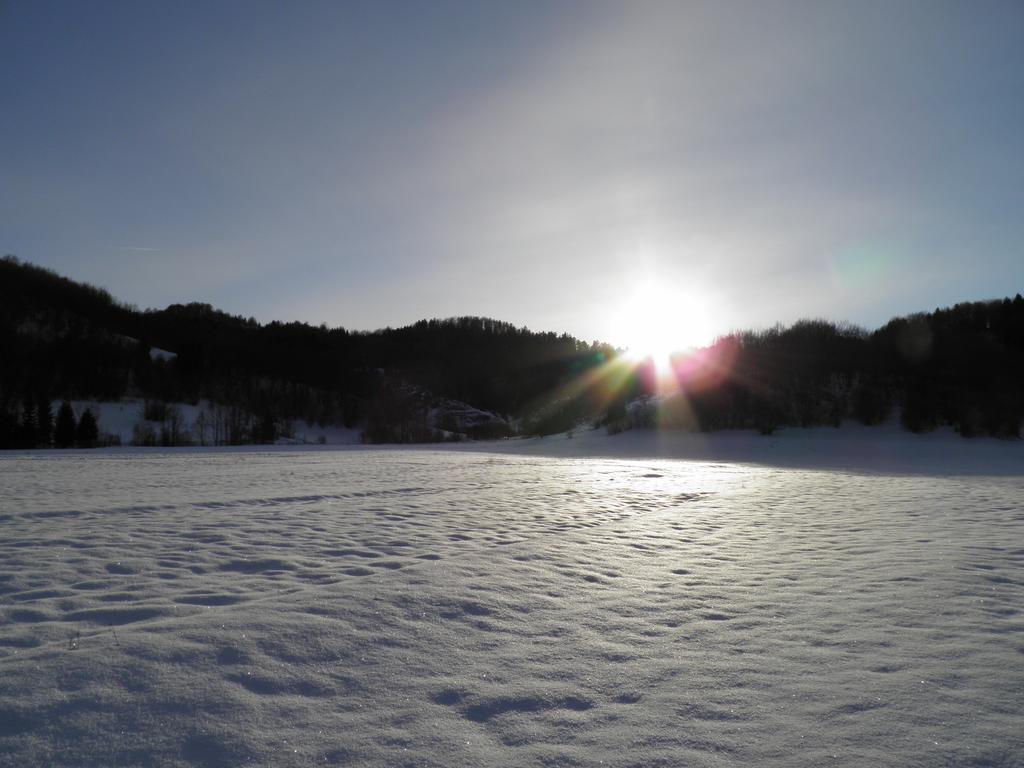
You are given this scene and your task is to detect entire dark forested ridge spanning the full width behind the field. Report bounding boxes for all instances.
[0,256,1024,449]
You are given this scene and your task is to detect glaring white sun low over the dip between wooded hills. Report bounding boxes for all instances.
[612,281,714,365]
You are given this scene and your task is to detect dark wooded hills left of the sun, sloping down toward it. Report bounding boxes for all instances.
[0,257,612,441]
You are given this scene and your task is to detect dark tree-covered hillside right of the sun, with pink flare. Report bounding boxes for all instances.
[609,301,1024,438]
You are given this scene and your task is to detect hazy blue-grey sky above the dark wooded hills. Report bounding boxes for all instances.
[0,0,1024,346]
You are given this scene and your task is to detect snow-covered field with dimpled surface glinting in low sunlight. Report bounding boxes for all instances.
[0,433,1024,767]
